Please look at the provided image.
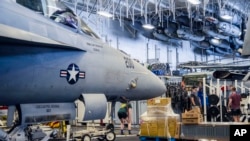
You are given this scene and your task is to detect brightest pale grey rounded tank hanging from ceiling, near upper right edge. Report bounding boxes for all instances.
[217,22,241,37]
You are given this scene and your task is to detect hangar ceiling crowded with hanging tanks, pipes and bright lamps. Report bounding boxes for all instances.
[64,0,250,57]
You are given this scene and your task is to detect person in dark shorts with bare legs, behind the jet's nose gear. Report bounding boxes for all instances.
[118,97,132,135]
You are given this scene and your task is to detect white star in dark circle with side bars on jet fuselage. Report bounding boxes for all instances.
[60,63,85,85]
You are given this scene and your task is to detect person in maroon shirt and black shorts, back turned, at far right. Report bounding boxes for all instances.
[228,87,241,122]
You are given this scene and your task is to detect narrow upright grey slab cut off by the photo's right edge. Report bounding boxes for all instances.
[241,14,250,56]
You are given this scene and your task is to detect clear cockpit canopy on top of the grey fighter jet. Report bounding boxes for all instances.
[16,0,99,38]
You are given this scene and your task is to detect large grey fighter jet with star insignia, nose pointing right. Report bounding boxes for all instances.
[0,0,166,139]
